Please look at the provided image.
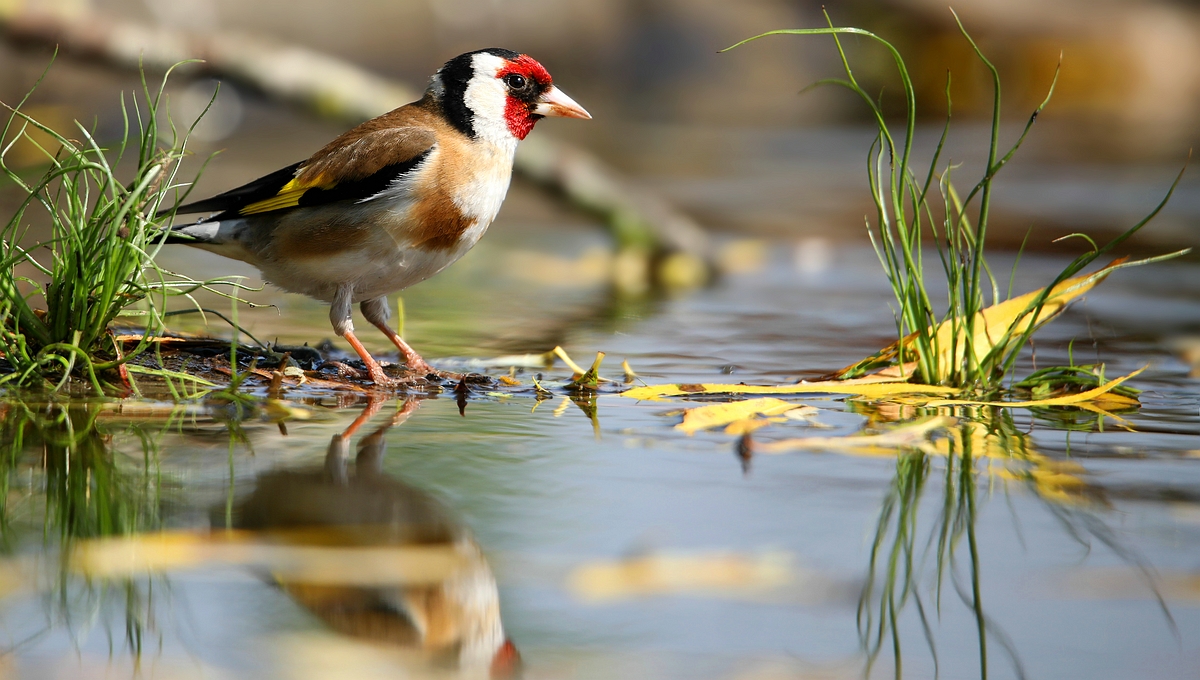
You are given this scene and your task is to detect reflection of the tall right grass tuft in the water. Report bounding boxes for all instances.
[857,404,1174,679]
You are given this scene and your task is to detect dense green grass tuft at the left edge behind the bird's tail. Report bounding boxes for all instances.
[0,58,246,392]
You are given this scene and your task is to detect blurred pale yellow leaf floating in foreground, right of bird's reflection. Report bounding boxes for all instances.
[566,553,796,602]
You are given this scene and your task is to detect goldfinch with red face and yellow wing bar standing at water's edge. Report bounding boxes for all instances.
[164,48,592,387]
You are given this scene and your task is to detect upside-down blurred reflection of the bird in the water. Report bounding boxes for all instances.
[235,399,521,678]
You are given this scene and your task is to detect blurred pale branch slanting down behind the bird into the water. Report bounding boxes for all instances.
[0,2,709,263]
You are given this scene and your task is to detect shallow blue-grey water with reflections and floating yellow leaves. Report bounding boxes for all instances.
[0,230,1200,679]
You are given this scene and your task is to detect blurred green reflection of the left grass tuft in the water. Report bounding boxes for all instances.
[0,402,171,658]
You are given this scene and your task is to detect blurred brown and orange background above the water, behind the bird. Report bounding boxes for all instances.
[7,0,1200,248]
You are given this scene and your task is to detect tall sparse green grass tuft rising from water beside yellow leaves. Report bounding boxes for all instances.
[727,13,1187,396]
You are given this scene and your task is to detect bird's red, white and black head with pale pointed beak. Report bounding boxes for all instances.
[428,47,592,143]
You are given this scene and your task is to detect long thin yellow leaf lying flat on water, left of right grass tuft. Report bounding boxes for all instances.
[620,377,959,399]
